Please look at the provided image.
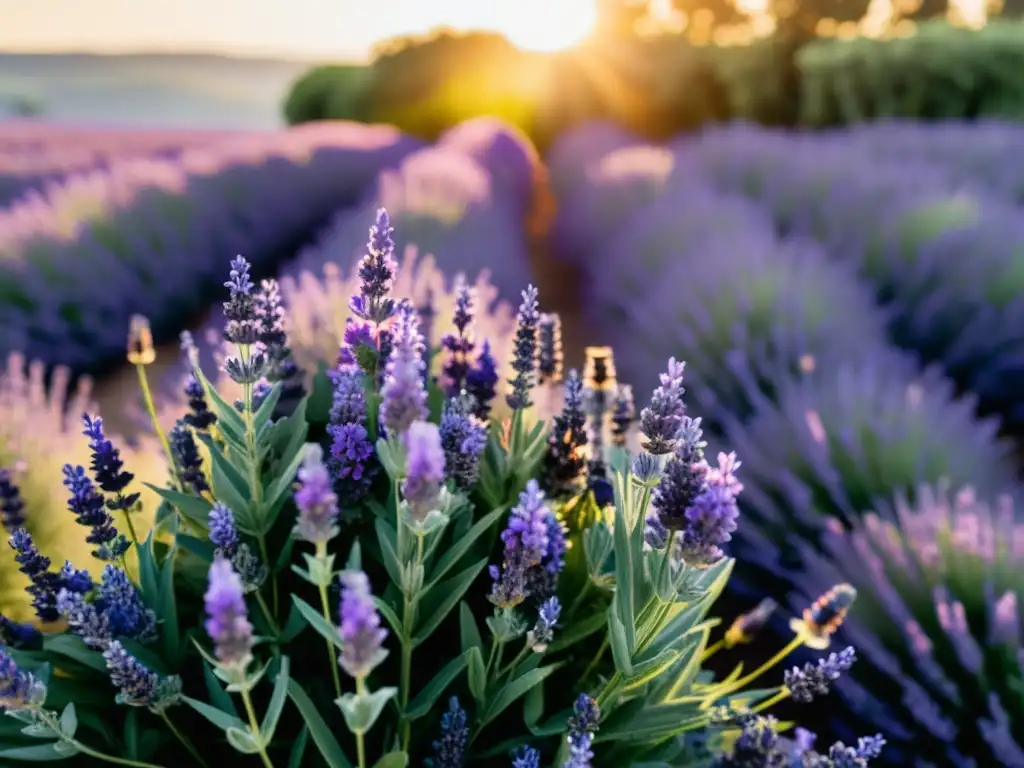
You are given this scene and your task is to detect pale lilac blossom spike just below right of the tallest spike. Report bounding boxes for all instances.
[380,305,427,437]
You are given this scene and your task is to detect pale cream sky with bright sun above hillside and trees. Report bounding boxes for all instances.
[0,0,594,59]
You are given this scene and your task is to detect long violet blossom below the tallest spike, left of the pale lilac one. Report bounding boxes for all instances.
[326,366,377,505]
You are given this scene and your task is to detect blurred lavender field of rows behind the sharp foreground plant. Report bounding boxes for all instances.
[0,119,1024,768]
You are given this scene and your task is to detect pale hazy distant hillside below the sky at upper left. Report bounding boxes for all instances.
[0,53,323,129]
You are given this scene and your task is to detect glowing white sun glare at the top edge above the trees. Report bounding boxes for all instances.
[495,0,597,52]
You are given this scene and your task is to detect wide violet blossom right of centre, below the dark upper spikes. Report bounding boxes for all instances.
[488,480,552,608]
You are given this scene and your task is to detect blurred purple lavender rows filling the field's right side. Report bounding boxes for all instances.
[549,117,1024,768]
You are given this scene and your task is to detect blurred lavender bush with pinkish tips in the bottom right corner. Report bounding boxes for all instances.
[788,485,1024,766]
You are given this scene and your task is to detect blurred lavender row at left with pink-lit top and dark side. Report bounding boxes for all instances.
[0,123,422,371]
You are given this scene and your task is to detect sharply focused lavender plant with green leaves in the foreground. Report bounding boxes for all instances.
[0,211,882,768]
